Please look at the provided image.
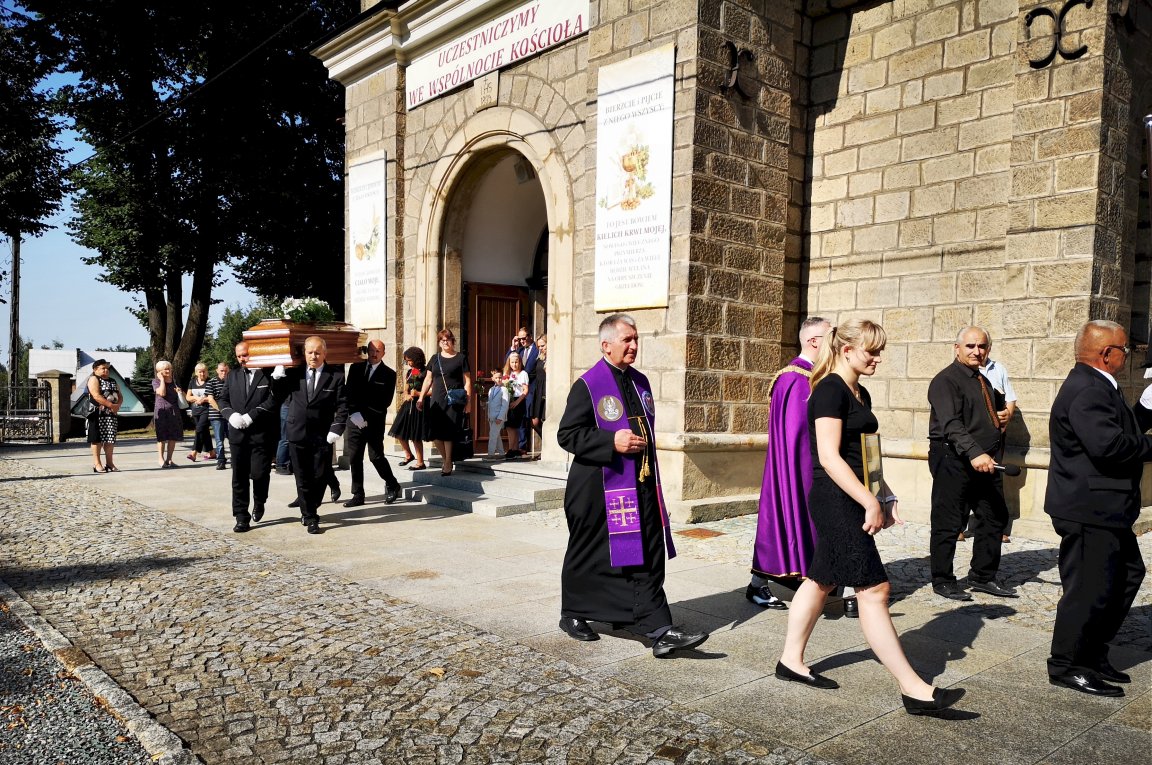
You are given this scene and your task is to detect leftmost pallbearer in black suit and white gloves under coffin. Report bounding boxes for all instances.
[217,342,280,533]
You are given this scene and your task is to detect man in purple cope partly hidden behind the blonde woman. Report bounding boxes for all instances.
[744,316,831,611]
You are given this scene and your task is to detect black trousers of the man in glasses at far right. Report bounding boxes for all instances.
[1048,518,1144,675]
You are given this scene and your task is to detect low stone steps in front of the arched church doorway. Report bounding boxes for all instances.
[404,460,568,517]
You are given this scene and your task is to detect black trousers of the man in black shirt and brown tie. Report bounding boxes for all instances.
[929,441,1008,585]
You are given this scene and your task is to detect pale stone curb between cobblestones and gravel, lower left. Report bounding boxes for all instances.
[0,581,204,765]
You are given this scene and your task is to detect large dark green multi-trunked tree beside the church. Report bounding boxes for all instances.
[14,0,359,379]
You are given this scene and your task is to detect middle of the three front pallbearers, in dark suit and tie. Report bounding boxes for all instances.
[272,335,348,533]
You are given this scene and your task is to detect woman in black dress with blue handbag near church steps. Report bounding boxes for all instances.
[416,330,472,476]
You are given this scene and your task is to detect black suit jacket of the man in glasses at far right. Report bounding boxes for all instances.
[1044,363,1152,527]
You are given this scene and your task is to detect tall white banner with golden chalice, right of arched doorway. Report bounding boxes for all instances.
[596,45,676,311]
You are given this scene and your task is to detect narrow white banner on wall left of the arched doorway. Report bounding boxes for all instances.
[348,157,388,327]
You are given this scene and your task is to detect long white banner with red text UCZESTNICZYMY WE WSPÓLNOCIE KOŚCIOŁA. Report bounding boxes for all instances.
[404,0,589,108]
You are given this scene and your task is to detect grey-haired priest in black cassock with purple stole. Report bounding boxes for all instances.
[558,313,708,658]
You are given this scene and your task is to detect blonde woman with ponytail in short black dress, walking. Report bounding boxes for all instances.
[775,320,964,714]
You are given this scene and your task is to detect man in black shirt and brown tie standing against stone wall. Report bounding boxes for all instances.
[929,327,1017,600]
